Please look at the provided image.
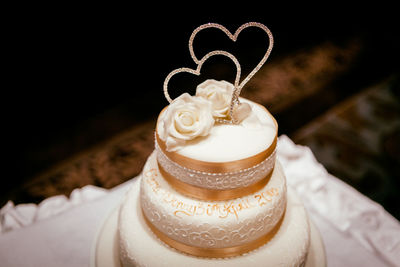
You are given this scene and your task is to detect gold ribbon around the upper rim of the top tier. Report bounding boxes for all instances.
[156,132,277,173]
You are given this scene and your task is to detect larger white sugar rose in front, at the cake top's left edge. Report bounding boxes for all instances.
[158,93,214,151]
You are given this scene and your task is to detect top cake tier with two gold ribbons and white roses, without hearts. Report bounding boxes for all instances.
[156,80,278,200]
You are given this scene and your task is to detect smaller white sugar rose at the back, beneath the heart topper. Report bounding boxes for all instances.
[196,79,234,118]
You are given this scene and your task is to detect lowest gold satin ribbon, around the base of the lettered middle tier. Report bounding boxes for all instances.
[142,211,285,258]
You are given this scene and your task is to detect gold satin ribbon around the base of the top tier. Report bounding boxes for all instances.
[158,163,273,201]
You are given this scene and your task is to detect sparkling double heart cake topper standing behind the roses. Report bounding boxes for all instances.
[163,22,274,123]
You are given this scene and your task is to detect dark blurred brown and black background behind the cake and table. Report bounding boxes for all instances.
[0,4,400,219]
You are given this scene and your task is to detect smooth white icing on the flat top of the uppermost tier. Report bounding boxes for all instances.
[157,98,277,162]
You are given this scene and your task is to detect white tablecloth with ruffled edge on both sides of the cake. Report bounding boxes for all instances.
[0,136,400,267]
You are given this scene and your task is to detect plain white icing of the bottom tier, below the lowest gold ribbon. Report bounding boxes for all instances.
[117,181,314,267]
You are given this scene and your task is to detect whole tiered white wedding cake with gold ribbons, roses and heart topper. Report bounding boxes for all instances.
[93,23,325,267]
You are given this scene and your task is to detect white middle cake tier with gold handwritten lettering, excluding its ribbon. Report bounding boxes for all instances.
[140,153,286,251]
